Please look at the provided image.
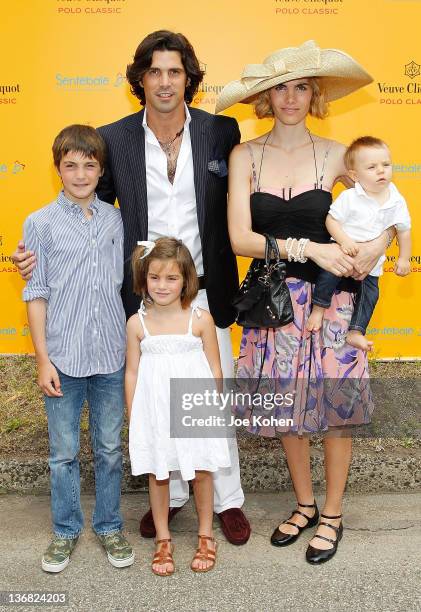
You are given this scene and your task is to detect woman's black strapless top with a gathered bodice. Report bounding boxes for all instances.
[250,189,332,283]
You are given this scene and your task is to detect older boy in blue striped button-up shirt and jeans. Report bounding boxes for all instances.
[23,125,134,572]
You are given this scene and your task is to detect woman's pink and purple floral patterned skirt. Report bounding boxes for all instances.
[235,278,373,436]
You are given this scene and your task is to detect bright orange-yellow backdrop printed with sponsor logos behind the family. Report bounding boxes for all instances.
[0,0,421,358]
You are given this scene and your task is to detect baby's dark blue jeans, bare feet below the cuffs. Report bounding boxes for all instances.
[312,270,379,335]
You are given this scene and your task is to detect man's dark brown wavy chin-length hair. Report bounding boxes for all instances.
[126,30,205,105]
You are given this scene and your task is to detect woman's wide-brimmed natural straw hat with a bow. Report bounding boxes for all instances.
[215,40,373,113]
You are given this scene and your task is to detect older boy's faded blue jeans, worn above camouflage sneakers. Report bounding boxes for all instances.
[45,368,124,538]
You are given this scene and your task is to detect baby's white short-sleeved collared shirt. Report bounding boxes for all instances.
[329,183,411,276]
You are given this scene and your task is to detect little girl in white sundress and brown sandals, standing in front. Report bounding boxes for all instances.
[125,238,230,576]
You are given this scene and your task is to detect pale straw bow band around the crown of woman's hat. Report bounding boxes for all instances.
[241,48,320,89]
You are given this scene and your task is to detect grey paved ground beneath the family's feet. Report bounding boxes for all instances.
[0,493,421,612]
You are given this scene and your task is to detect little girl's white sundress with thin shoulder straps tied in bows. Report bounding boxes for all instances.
[129,303,231,480]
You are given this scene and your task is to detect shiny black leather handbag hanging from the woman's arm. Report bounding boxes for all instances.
[232,234,294,328]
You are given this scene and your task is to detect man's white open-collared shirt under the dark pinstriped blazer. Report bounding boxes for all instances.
[143,105,203,276]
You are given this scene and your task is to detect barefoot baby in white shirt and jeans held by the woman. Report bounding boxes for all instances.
[307,136,411,351]
